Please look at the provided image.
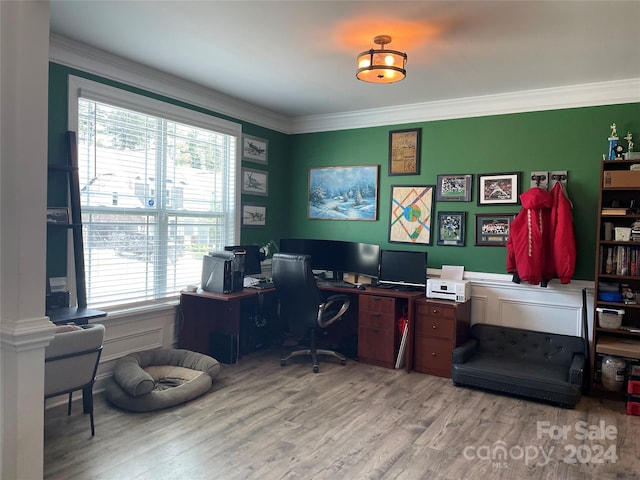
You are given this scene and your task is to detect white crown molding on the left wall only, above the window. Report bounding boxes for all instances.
[49,33,292,133]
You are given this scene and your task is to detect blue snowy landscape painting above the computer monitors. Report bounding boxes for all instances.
[307,165,379,220]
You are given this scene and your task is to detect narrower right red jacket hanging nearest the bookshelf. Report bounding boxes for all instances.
[551,182,576,283]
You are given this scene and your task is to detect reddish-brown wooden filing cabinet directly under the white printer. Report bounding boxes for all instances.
[413,298,471,378]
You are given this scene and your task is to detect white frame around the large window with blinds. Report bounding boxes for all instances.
[67,75,242,310]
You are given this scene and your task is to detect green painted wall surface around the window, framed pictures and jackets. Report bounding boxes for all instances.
[47,63,640,280]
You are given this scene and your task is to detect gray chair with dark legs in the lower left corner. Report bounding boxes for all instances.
[44,324,104,436]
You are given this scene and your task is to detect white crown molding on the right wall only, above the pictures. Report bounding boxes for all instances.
[293,78,640,133]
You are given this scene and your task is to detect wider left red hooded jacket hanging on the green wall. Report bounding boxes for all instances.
[507,187,554,285]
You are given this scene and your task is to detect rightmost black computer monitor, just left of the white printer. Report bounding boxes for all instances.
[378,250,427,287]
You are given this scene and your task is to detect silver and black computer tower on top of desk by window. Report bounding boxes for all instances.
[200,252,244,293]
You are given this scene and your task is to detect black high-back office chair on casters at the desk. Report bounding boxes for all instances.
[271,253,350,373]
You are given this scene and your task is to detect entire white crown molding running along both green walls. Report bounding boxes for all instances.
[49,34,640,134]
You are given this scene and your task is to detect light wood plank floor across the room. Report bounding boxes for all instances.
[44,350,640,480]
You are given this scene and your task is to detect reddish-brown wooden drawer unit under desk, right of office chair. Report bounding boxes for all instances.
[358,295,407,368]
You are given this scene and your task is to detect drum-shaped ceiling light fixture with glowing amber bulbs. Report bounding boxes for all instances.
[356,35,407,83]
